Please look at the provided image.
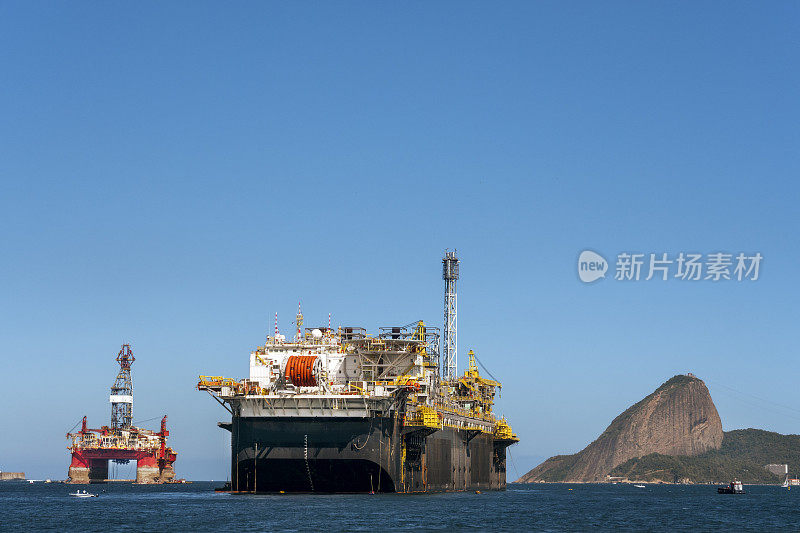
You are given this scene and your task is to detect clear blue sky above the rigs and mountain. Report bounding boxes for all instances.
[0,1,800,479]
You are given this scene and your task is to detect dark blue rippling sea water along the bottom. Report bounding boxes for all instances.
[0,482,800,532]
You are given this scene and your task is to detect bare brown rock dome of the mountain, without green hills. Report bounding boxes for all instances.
[518,375,723,483]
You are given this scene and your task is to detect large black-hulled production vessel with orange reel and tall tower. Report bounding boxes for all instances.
[197,252,519,493]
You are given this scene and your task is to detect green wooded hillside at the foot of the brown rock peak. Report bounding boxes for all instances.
[611,429,800,483]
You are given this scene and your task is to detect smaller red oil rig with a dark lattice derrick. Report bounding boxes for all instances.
[67,344,177,483]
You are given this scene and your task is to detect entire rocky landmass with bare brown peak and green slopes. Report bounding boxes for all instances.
[517,374,800,483]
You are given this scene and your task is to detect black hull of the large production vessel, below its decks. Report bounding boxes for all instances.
[228,416,508,493]
